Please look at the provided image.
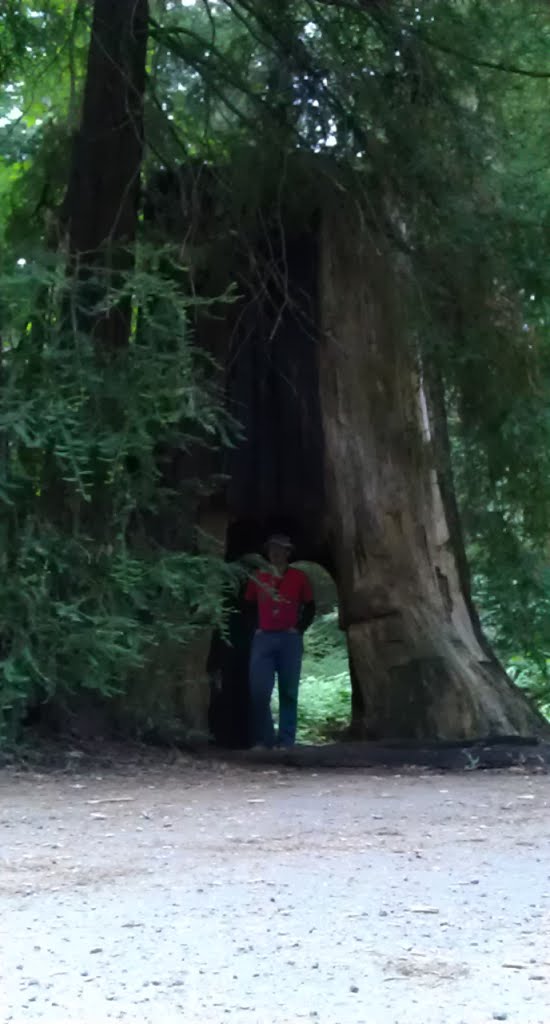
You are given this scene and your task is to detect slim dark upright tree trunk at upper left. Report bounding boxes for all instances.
[64,0,149,348]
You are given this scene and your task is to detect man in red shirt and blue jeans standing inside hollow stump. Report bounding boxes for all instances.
[245,534,315,748]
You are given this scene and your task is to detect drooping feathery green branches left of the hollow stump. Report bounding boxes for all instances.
[0,252,232,741]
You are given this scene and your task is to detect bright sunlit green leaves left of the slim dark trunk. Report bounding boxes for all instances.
[0,0,89,245]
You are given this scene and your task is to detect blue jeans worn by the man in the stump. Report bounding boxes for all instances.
[250,631,303,746]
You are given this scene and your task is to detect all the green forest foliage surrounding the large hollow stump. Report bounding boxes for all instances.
[0,0,550,738]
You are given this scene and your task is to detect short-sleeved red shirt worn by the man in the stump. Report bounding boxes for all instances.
[245,567,313,632]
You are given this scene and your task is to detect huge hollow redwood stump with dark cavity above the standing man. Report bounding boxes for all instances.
[147,157,546,739]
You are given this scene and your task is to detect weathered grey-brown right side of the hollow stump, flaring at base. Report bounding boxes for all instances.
[320,201,547,739]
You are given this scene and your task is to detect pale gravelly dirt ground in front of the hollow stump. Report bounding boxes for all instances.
[0,762,550,1024]
